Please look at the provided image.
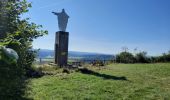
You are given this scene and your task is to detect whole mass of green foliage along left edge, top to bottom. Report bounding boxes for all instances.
[0,0,48,100]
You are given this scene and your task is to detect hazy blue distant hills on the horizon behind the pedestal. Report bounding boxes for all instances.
[38,49,114,60]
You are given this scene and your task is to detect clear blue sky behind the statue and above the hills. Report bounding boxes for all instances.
[24,0,170,55]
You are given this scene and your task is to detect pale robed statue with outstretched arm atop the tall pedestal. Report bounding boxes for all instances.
[52,9,69,32]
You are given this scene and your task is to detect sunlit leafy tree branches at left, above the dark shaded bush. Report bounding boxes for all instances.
[1,0,48,69]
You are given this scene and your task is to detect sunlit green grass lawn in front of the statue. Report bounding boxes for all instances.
[25,63,170,100]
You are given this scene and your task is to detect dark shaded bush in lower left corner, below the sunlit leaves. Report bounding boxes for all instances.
[0,47,24,100]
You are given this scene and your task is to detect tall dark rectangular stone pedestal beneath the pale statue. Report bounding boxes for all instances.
[54,31,69,67]
